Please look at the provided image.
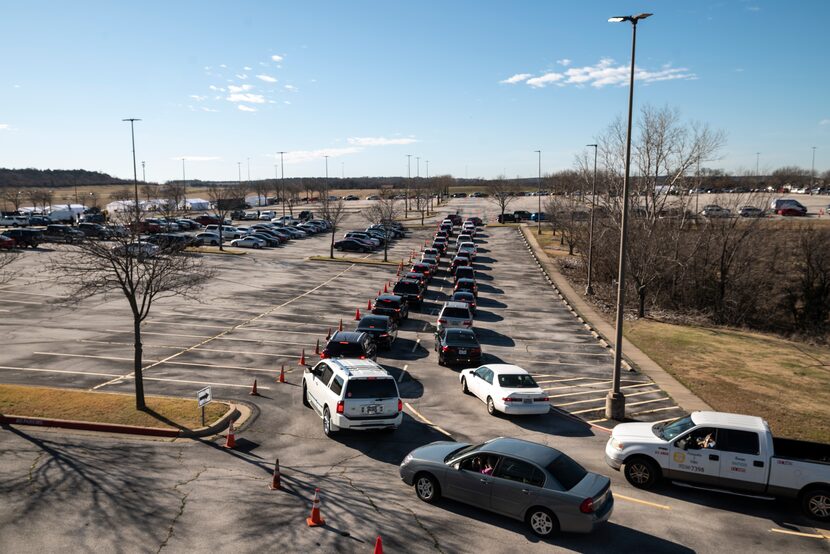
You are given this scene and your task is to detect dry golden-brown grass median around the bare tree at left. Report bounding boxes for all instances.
[0,385,229,429]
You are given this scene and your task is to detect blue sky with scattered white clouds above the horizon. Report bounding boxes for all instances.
[0,0,830,181]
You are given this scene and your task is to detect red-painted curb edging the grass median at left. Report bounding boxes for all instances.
[0,398,242,439]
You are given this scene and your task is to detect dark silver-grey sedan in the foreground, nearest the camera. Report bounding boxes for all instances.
[400,437,614,537]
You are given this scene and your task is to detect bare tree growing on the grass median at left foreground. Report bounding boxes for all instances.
[51,211,213,410]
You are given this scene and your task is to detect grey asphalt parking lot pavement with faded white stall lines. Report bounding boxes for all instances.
[0,198,830,552]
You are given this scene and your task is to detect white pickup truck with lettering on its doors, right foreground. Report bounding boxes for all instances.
[605,412,830,521]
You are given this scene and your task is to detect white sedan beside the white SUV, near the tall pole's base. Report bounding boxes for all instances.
[458,364,550,415]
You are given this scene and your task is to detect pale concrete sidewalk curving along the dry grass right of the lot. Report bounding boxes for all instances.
[520,226,712,412]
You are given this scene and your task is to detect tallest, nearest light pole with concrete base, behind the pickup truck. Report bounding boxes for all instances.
[605,13,651,421]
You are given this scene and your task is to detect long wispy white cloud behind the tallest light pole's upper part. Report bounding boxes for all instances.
[510,58,697,88]
